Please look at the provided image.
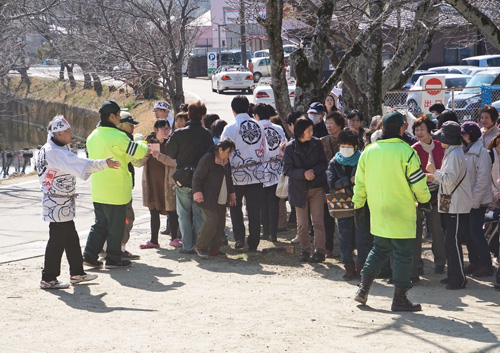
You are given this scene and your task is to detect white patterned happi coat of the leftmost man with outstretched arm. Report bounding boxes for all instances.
[36,139,108,222]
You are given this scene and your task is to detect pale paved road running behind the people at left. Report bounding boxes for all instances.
[0,66,252,263]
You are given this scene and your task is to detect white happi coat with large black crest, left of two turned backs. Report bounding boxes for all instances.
[220,113,269,185]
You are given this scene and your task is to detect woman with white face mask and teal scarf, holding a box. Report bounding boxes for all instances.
[328,129,373,280]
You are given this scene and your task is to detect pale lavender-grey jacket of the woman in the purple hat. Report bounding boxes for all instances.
[465,140,493,208]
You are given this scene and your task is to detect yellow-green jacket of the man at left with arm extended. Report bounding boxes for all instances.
[87,126,148,205]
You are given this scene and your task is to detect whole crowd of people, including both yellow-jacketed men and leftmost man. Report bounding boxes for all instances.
[37,95,500,311]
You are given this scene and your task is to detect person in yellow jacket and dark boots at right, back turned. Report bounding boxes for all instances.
[353,111,431,311]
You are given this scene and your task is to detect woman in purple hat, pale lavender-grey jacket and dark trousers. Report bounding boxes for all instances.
[461,121,493,277]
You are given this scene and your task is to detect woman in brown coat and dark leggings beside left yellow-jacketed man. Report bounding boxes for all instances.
[133,119,179,249]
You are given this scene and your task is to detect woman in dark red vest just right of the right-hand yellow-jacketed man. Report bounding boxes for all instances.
[411,115,446,276]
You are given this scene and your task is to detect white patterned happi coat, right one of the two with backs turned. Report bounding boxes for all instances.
[259,120,286,187]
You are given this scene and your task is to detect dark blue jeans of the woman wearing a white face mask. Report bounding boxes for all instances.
[337,217,373,264]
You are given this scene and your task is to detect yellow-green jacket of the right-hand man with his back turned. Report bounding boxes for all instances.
[353,138,431,239]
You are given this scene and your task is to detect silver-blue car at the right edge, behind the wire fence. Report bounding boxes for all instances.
[446,69,500,121]
